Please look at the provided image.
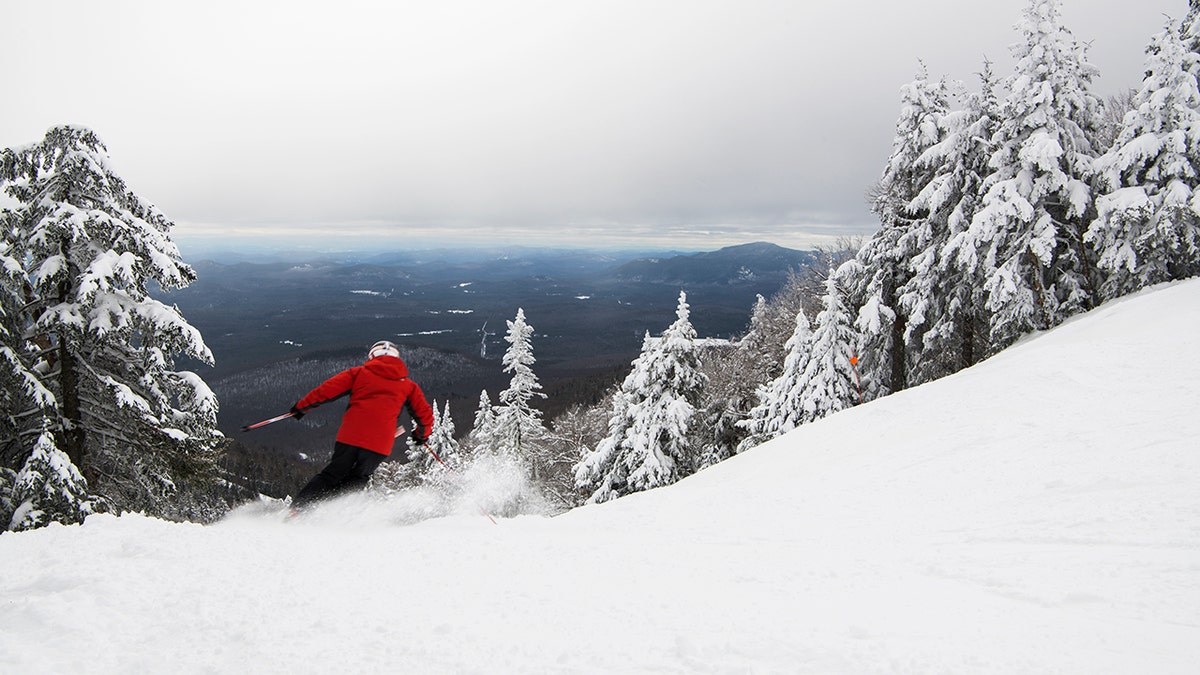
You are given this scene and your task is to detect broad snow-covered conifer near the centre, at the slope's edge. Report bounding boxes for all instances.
[575,292,704,503]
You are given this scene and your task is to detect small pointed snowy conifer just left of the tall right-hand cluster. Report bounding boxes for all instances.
[796,270,859,424]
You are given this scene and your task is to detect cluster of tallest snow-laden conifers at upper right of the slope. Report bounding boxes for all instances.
[834,0,1200,396]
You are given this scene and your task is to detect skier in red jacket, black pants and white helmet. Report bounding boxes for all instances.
[292,340,433,506]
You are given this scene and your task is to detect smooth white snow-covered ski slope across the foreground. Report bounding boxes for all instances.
[7,281,1200,674]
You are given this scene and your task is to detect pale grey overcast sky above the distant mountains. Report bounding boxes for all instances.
[0,0,1187,255]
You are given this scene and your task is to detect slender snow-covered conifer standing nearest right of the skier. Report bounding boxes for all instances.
[491,309,546,461]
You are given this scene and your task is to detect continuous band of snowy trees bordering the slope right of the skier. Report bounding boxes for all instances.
[396,0,1200,508]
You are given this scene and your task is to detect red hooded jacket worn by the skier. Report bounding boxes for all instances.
[296,356,433,455]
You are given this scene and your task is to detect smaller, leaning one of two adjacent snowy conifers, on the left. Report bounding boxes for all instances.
[740,311,812,450]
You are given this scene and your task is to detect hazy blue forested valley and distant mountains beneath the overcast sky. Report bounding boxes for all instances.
[163,243,815,442]
